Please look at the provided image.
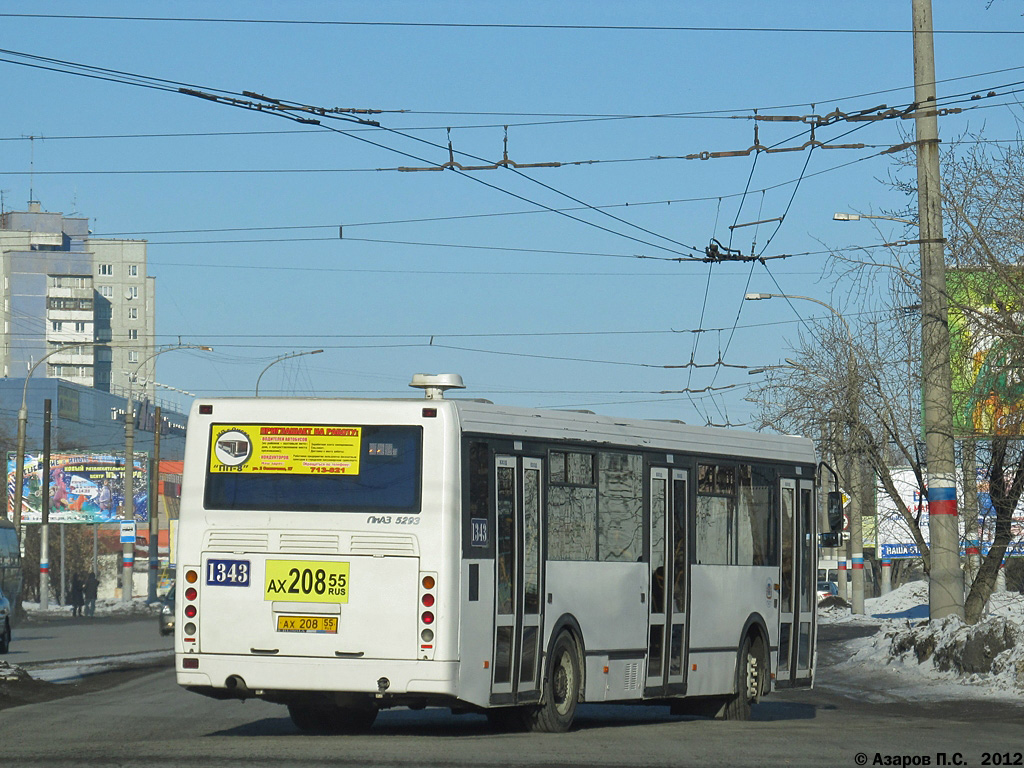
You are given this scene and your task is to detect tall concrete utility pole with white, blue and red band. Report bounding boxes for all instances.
[911,0,964,620]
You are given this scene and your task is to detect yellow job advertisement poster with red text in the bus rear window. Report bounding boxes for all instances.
[210,424,362,475]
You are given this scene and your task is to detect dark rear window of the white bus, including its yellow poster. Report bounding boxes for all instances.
[204,424,423,514]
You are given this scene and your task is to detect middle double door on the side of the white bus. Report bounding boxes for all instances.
[644,467,689,696]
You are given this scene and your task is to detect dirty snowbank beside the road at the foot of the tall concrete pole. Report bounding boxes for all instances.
[818,582,1024,701]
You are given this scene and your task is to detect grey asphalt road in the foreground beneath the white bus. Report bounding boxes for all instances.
[0,627,1024,767]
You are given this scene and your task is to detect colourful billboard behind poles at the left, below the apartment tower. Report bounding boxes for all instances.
[7,452,150,523]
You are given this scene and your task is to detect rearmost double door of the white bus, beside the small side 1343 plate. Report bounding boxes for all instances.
[490,456,543,703]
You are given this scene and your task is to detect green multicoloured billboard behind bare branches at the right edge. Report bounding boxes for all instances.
[946,269,1024,437]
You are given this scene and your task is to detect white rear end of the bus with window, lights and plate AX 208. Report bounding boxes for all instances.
[175,398,458,731]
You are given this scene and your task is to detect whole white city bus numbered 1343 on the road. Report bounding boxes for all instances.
[174,374,816,732]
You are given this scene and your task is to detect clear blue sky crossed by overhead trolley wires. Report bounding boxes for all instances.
[0,0,1024,424]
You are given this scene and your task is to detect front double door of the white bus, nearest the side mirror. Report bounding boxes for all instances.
[776,478,817,687]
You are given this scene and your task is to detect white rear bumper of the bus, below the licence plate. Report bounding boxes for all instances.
[174,653,459,698]
